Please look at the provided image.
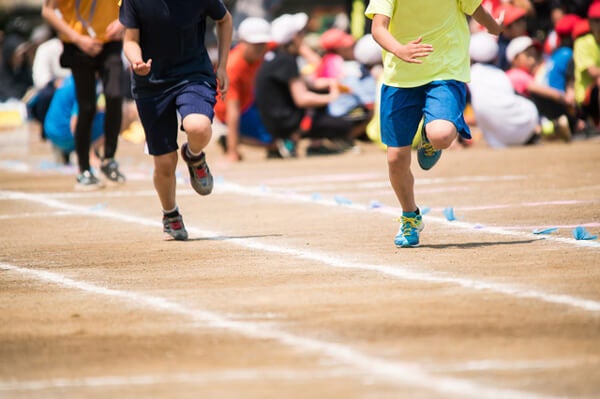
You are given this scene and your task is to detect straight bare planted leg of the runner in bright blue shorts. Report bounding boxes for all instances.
[387,146,417,212]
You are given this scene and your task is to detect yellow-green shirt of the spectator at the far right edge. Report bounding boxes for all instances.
[573,33,600,104]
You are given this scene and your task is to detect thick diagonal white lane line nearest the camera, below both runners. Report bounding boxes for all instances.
[0,262,560,399]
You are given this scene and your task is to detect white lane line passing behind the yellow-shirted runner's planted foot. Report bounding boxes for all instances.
[217,182,600,248]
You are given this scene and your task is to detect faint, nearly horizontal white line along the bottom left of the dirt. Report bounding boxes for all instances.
[0,369,360,391]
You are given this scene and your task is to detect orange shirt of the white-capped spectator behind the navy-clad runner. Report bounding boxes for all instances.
[215,43,262,122]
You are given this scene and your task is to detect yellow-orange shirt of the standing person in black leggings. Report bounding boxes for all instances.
[58,0,120,42]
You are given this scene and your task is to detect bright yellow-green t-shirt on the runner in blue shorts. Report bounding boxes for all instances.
[365,0,481,87]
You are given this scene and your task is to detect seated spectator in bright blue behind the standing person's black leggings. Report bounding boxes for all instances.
[44,75,104,166]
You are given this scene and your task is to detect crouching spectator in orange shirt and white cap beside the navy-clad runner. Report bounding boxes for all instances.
[215,17,280,162]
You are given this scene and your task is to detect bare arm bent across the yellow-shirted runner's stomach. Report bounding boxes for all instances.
[371,14,433,64]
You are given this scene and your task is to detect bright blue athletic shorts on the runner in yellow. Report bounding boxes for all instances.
[380,80,471,147]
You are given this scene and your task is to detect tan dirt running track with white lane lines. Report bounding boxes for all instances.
[0,126,600,399]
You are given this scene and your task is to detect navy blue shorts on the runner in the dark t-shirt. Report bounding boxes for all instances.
[135,82,217,155]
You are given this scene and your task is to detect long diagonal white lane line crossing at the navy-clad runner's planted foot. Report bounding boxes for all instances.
[0,191,600,312]
